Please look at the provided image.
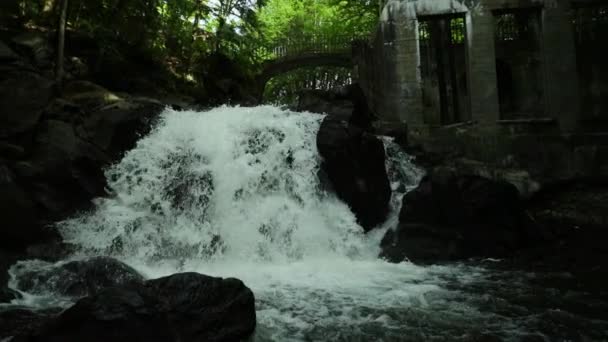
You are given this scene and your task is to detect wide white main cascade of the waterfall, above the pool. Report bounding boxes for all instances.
[60,106,377,264]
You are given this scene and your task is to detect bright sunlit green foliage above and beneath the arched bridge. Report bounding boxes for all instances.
[259,0,378,104]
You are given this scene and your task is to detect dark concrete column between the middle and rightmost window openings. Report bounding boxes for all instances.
[542,0,580,132]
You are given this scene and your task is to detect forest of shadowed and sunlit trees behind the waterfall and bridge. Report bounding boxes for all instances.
[0,0,378,105]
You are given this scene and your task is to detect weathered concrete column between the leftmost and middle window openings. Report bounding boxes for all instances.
[467,7,499,125]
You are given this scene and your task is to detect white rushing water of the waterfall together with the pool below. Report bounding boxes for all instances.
[4,106,606,341]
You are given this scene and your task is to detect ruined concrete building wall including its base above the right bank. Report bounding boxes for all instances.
[359,0,608,187]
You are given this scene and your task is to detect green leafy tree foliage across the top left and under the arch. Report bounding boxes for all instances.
[11,0,378,101]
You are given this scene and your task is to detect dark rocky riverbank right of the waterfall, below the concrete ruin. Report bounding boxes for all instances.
[299,87,608,283]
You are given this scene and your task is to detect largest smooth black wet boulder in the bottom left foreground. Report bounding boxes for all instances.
[15,273,256,342]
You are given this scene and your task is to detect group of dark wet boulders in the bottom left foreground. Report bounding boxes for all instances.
[0,257,256,341]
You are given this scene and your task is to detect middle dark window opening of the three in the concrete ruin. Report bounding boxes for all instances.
[494,8,544,119]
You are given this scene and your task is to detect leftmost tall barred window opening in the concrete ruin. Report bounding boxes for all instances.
[418,15,470,125]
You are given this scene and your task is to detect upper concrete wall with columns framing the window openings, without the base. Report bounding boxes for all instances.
[360,0,580,131]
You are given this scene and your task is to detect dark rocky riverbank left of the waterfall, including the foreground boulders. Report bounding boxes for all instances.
[0,31,256,341]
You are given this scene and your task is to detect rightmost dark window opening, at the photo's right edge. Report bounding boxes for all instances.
[572,3,608,120]
